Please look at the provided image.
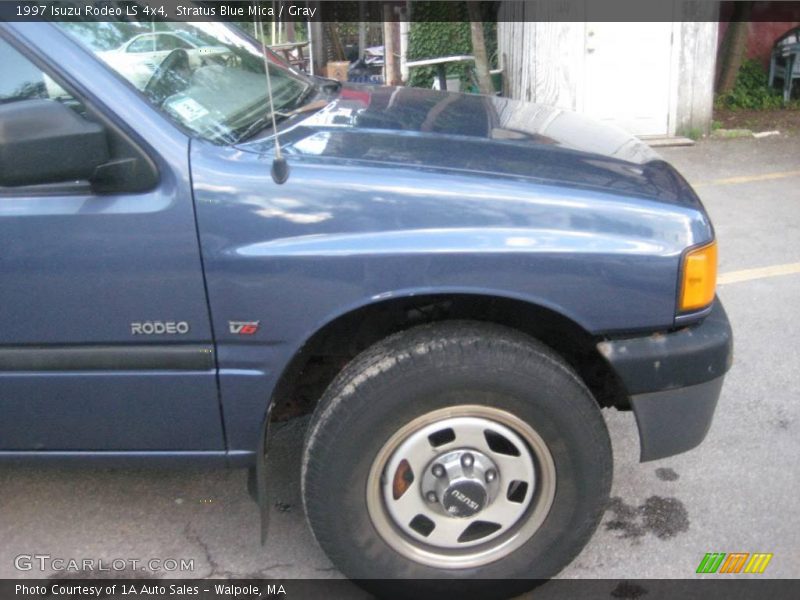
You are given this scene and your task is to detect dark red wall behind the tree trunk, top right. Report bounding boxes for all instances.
[717,2,800,69]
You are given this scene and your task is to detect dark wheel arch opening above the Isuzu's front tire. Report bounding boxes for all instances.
[270,290,628,420]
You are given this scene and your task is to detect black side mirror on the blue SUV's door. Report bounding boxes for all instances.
[0,100,109,186]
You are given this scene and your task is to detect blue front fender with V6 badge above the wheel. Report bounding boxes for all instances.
[191,141,710,451]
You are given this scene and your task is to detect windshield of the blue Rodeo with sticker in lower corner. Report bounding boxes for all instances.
[58,22,312,143]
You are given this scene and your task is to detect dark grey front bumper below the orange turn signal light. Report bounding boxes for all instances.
[597,299,733,462]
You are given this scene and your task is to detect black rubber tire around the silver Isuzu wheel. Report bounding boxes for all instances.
[302,321,612,596]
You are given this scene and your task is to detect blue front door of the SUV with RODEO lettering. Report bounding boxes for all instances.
[0,29,224,454]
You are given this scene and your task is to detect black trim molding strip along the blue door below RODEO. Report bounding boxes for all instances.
[0,344,215,371]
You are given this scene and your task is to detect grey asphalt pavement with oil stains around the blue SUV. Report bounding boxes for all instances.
[0,137,800,596]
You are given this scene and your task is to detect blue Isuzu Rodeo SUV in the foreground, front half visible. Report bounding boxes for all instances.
[0,15,732,597]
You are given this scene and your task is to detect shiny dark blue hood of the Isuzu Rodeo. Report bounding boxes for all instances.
[242,85,699,205]
